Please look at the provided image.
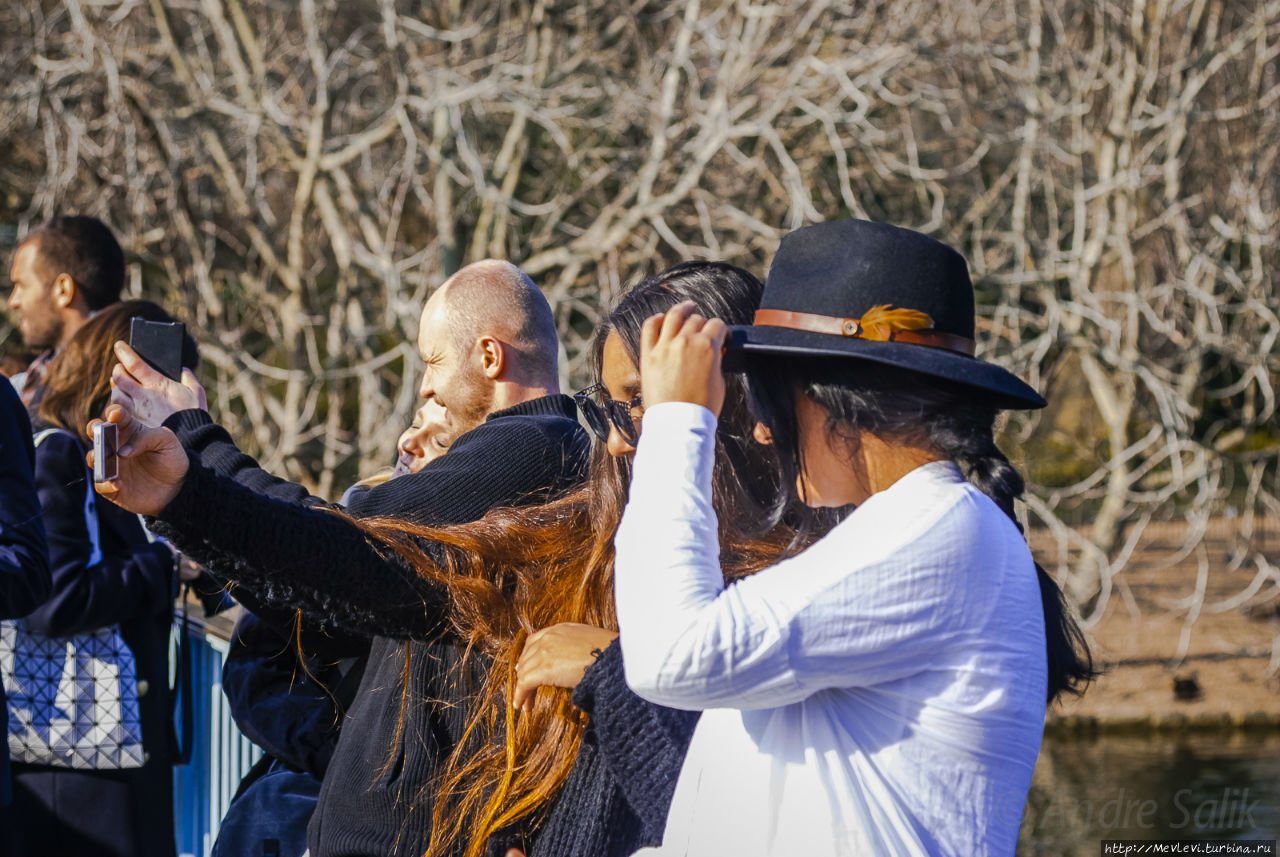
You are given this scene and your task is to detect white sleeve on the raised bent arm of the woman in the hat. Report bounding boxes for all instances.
[614,403,972,709]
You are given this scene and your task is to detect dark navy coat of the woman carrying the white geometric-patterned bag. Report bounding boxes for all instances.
[5,423,177,857]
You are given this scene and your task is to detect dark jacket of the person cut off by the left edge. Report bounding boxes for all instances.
[0,379,49,806]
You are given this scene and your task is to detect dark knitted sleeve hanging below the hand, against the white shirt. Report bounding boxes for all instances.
[573,640,700,845]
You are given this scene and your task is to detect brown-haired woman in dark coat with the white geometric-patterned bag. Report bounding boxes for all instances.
[0,301,196,857]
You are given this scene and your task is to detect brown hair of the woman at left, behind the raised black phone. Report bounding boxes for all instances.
[37,301,196,445]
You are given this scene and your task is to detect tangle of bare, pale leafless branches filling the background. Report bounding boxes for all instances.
[0,0,1280,642]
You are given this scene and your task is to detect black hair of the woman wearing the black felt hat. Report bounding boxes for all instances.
[748,356,1097,702]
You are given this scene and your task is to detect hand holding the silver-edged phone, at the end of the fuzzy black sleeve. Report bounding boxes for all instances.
[86,404,191,515]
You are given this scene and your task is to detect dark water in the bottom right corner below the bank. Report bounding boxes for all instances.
[1018,732,1280,857]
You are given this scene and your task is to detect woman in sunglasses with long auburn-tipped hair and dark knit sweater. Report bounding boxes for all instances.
[380,262,794,857]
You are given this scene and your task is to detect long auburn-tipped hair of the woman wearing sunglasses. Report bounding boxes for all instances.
[350,262,794,857]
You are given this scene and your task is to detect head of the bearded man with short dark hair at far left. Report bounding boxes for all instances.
[9,215,124,408]
